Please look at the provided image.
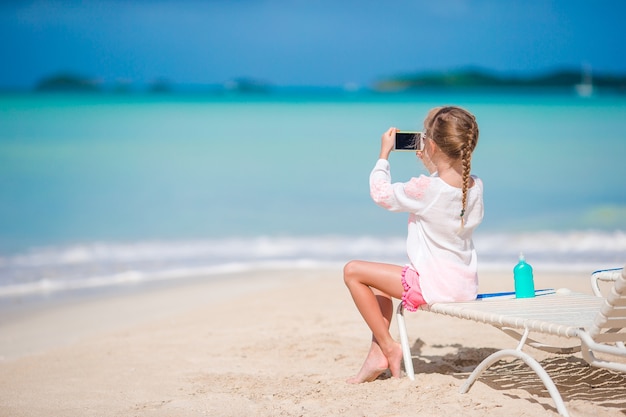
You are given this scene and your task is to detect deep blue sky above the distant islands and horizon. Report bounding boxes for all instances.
[0,0,626,88]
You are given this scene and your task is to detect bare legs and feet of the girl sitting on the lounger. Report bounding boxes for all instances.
[344,261,402,383]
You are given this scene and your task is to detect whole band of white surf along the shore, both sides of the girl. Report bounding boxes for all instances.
[0,231,626,297]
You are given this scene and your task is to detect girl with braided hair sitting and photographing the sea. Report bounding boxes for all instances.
[344,106,483,383]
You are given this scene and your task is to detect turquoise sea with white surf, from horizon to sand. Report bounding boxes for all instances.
[0,90,626,303]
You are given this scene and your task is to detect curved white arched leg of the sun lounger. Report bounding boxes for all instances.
[461,349,569,417]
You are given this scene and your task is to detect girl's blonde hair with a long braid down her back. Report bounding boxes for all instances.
[424,106,479,227]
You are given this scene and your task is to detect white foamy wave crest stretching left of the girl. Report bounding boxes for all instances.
[0,236,404,268]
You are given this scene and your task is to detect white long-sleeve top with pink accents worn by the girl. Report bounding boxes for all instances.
[370,159,484,303]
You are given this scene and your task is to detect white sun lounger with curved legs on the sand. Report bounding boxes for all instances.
[396,268,626,416]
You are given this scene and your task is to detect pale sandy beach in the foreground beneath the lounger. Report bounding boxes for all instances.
[0,266,626,417]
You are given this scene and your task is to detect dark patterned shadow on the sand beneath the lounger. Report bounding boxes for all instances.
[411,339,626,415]
